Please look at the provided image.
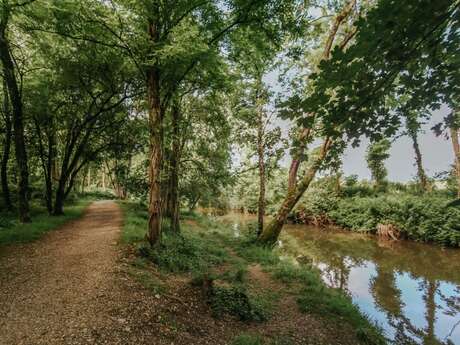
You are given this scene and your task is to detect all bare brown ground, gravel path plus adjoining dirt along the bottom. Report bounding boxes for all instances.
[0,201,366,345]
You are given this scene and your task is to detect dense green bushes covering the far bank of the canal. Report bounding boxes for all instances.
[292,181,460,247]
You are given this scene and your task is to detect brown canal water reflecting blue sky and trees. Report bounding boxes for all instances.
[223,214,460,345]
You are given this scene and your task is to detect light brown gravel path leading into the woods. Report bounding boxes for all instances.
[0,201,155,345]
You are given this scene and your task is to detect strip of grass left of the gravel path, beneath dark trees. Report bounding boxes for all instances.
[0,198,92,245]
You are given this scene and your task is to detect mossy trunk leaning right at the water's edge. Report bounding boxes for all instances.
[257,138,332,246]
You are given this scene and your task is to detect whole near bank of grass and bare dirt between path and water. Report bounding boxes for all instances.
[117,203,385,345]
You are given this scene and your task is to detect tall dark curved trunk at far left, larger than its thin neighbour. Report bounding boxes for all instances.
[0,16,30,223]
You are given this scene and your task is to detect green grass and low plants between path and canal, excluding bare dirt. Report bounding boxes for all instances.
[121,202,385,344]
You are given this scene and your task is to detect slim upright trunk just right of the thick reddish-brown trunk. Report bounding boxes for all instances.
[169,104,181,233]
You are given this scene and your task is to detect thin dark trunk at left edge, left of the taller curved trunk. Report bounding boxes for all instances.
[0,80,13,210]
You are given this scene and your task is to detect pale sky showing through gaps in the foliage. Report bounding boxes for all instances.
[264,71,454,182]
